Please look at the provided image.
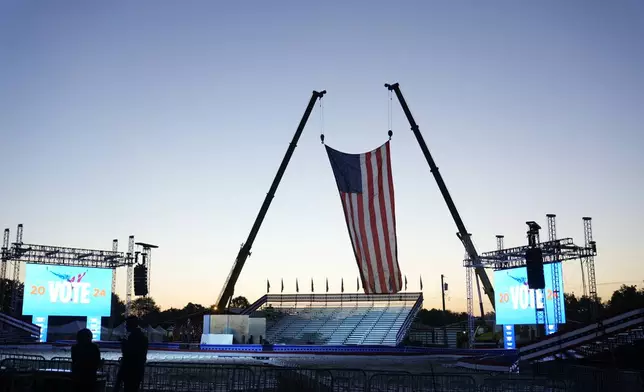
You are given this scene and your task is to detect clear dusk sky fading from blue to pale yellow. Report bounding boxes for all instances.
[0,0,644,310]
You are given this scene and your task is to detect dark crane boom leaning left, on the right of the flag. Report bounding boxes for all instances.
[385,83,495,313]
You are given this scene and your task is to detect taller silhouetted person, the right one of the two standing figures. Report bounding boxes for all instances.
[116,316,148,392]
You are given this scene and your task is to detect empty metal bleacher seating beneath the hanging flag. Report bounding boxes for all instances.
[245,293,423,346]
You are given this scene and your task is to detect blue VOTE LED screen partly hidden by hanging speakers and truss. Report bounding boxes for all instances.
[494,262,566,325]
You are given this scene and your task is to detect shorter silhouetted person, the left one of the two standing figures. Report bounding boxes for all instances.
[72,328,101,392]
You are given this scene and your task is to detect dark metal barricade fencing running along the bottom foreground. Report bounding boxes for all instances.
[0,353,643,392]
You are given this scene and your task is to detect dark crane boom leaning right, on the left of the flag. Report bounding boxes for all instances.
[215,90,326,312]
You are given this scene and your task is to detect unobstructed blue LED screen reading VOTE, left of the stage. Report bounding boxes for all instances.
[22,264,112,317]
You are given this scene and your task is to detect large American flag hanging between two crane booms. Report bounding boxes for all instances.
[326,142,402,294]
